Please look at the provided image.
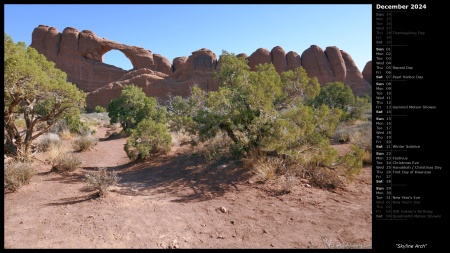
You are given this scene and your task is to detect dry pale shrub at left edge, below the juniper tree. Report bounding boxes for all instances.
[4,162,35,192]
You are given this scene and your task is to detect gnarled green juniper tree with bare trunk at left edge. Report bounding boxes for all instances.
[3,34,86,160]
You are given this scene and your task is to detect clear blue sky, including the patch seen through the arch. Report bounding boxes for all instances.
[4,4,372,71]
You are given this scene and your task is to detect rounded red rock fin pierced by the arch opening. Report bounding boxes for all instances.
[31,25,172,92]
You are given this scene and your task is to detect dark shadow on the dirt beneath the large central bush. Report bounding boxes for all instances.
[108,154,252,202]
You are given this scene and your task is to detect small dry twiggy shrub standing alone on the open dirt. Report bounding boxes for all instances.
[85,167,120,197]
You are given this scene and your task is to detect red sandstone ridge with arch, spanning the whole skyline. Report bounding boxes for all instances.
[31,25,372,110]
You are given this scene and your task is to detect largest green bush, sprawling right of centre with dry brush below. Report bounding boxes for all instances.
[167,51,364,191]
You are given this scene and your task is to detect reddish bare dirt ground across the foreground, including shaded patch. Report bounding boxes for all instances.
[4,125,372,249]
